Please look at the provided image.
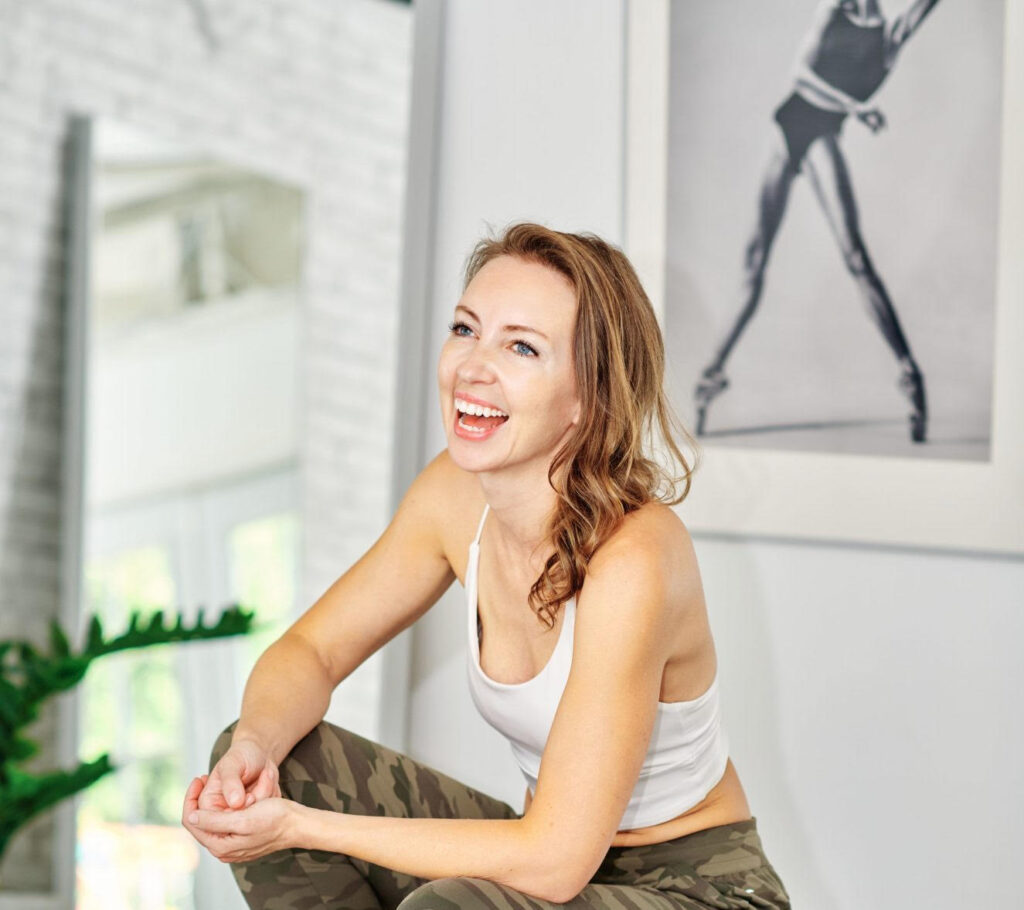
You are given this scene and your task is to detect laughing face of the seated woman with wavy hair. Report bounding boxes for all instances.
[437,256,580,472]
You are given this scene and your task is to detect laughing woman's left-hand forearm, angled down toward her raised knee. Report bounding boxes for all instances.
[233,634,333,765]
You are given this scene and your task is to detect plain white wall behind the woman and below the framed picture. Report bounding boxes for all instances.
[409,0,1024,910]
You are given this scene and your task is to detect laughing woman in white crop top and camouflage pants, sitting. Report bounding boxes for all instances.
[182,224,790,910]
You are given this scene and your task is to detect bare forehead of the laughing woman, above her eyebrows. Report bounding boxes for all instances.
[460,256,577,331]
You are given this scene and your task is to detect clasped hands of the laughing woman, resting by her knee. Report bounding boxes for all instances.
[181,740,301,863]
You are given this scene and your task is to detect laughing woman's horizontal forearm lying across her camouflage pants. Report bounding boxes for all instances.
[293,804,575,903]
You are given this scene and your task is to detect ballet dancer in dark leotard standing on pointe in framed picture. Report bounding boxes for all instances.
[694,0,938,442]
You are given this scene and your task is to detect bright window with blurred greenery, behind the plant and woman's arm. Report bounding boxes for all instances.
[76,472,299,910]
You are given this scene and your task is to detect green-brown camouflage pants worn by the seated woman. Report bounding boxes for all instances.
[205,723,790,910]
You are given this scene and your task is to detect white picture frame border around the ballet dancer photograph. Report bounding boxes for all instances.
[624,0,1024,556]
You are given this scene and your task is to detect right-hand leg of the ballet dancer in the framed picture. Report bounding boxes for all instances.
[804,135,927,442]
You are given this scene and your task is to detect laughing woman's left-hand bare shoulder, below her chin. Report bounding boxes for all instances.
[399,448,485,578]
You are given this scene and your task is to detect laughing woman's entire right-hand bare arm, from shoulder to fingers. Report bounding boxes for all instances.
[185,510,702,903]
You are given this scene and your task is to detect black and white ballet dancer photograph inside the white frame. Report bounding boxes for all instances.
[665,0,1004,462]
